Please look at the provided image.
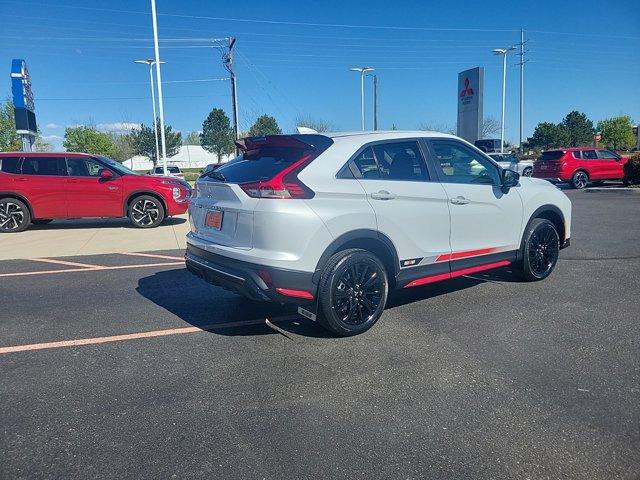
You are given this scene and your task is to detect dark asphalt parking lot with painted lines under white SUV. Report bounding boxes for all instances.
[0,191,640,479]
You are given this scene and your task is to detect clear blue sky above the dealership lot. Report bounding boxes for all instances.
[0,0,640,148]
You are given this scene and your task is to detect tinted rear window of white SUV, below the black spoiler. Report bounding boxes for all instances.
[205,135,333,183]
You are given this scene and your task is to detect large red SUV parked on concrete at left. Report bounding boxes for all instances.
[0,152,191,232]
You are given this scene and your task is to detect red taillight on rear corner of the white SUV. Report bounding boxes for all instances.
[240,154,316,199]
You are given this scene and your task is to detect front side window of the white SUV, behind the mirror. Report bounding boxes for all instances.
[431,140,500,185]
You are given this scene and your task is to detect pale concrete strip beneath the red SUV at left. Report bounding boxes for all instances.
[0,214,189,260]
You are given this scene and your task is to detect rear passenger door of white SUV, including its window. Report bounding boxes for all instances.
[351,139,451,284]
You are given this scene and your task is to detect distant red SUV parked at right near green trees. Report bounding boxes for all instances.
[533,147,627,188]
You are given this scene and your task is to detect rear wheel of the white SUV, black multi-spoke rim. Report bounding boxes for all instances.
[318,249,389,337]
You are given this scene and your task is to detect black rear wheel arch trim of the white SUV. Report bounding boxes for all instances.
[313,229,400,284]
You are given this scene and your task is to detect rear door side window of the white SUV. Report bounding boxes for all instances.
[373,142,429,182]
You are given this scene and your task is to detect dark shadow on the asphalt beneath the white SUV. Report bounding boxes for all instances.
[136,268,517,338]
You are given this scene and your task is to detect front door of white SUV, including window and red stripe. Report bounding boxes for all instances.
[427,138,523,271]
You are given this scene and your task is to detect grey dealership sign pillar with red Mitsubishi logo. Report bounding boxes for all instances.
[457,67,484,143]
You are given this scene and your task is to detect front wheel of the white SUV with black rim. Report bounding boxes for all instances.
[517,218,560,282]
